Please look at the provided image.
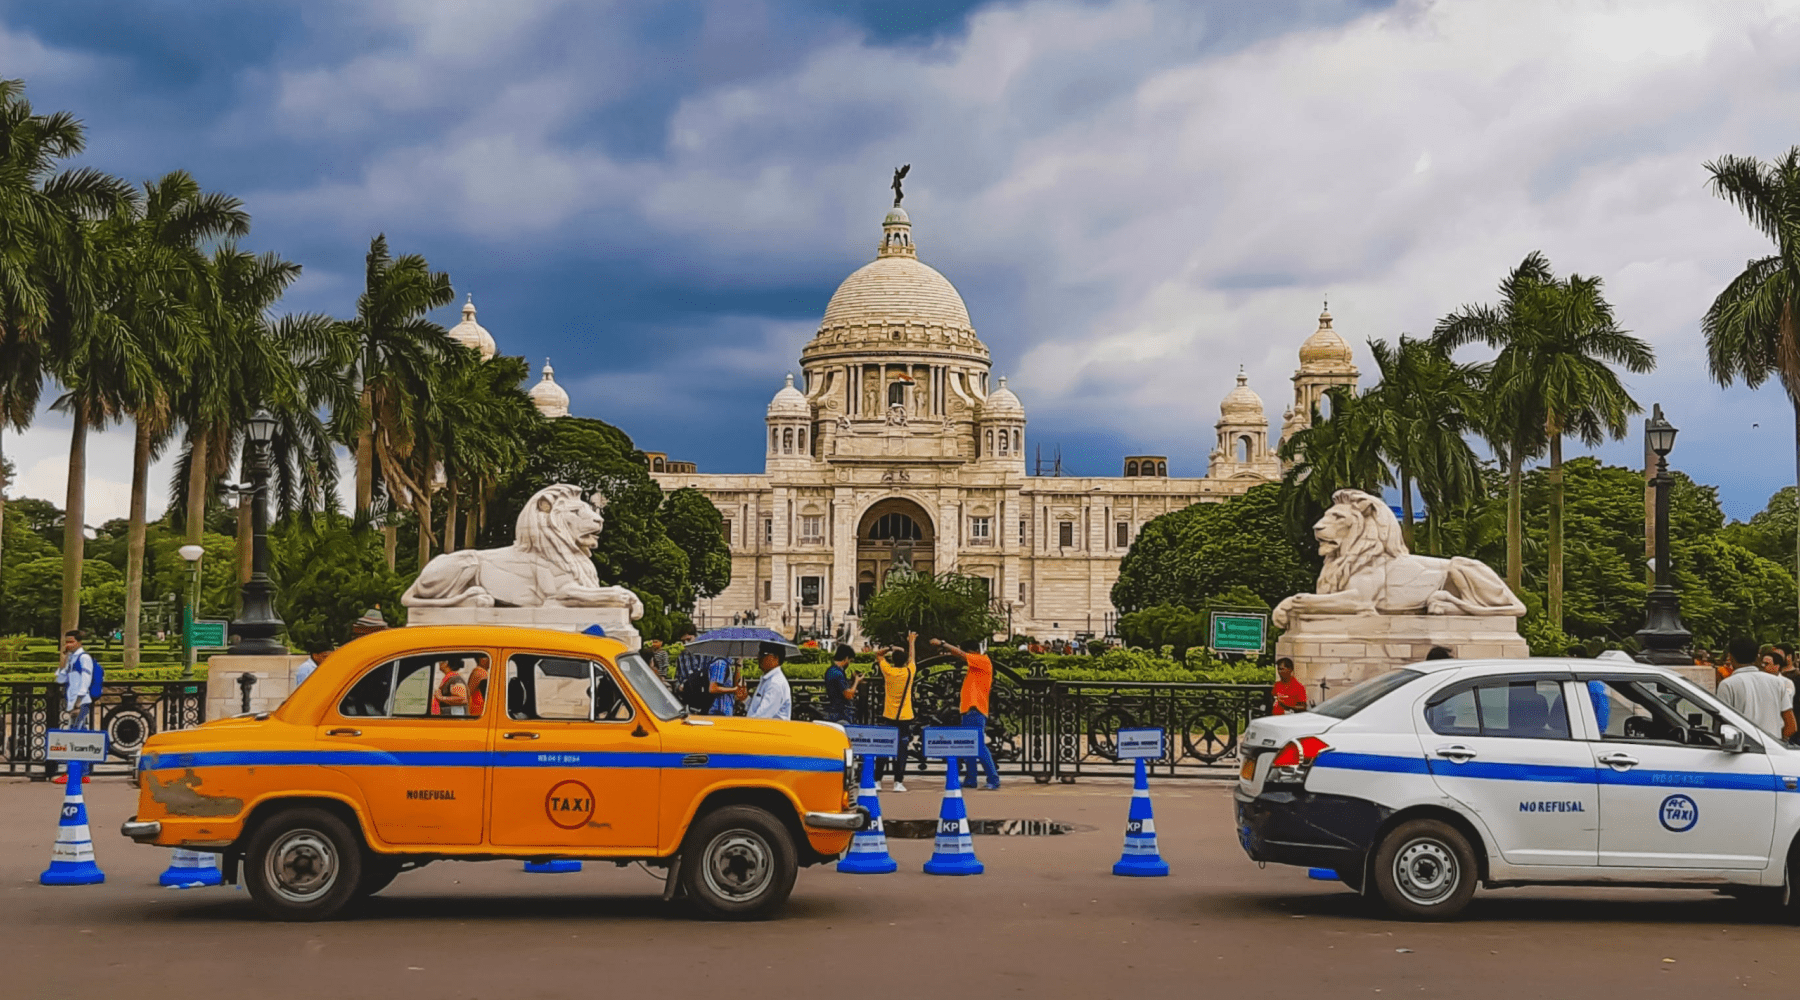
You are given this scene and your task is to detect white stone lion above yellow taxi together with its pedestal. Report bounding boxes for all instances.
[400,484,644,649]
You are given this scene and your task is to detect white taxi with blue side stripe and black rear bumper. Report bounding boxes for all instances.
[1237,660,1800,919]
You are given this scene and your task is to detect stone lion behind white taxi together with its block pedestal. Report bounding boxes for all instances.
[1273,489,1532,701]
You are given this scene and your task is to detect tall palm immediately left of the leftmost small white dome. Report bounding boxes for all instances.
[333,236,455,552]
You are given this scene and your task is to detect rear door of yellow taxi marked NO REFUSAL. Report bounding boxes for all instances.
[317,649,491,845]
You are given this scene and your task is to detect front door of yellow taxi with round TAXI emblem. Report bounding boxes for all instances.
[490,649,662,851]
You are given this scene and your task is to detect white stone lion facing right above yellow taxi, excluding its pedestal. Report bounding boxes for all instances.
[400,484,644,621]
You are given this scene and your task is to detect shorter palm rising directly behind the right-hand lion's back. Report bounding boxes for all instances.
[1363,335,1483,549]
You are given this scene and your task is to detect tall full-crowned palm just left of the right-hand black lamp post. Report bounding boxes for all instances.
[1435,252,1656,628]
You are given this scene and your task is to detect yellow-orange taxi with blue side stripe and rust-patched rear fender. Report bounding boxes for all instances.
[122,626,868,921]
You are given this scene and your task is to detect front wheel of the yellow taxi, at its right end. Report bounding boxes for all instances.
[680,806,799,921]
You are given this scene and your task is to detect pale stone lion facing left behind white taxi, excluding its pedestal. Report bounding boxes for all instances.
[1271,489,1525,628]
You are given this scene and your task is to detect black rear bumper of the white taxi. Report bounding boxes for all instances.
[1237,788,1393,872]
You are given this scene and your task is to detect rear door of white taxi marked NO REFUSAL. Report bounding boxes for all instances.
[1418,673,1600,865]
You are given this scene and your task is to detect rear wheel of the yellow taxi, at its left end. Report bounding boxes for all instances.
[243,806,364,921]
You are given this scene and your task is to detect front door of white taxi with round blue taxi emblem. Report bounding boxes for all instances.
[1588,674,1777,871]
